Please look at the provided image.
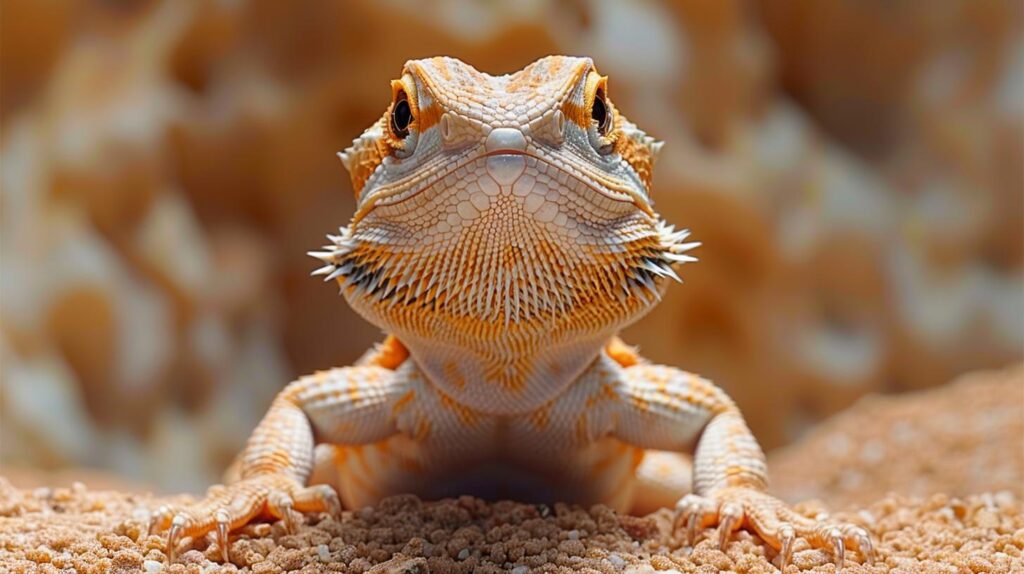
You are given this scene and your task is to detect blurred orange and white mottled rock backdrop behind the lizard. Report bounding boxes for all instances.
[0,0,1024,491]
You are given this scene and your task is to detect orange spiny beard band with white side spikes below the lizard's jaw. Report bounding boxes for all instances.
[309,221,699,326]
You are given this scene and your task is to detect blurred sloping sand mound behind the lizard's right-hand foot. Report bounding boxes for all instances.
[768,365,1024,507]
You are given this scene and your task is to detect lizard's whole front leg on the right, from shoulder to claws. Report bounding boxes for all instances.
[599,359,873,571]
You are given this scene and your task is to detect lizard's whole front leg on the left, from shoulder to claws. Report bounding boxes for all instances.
[151,364,412,562]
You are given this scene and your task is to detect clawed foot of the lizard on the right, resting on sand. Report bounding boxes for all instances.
[674,488,874,572]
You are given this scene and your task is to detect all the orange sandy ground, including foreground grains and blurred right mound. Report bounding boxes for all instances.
[0,367,1024,574]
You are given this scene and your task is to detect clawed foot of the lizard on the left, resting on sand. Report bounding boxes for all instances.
[150,475,341,563]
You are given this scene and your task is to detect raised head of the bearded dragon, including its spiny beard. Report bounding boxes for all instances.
[312,56,695,358]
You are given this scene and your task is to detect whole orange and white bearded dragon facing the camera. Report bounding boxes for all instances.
[153,56,870,565]
